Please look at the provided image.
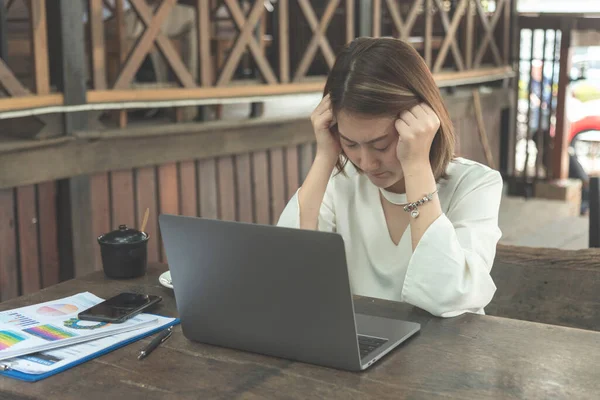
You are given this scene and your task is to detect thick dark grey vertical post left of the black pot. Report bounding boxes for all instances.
[50,0,94,280]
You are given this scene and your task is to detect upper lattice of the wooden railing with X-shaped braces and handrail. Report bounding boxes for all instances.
[0,0,514,130]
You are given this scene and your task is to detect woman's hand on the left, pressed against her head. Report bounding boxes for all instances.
[310,94,342,161]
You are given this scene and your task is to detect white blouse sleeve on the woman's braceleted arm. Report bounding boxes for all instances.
[402,170,502,317]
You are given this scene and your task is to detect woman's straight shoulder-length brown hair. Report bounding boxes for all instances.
[323,38,455,180]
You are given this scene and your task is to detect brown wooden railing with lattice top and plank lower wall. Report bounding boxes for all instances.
[0,0,514,299]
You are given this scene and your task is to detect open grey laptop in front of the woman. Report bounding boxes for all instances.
[159,214,420,371]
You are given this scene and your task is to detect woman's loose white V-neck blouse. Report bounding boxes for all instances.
[277,158,502,317]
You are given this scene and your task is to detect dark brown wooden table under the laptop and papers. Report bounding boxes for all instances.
[0,265,600,400]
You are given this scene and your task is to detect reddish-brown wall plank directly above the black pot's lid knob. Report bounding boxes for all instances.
[110,169,136,230]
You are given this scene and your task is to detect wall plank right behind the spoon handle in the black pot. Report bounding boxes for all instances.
[135,167,160,262]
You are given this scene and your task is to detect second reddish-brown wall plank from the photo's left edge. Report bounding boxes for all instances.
[16,185,42,294]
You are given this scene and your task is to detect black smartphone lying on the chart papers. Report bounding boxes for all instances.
[78,293,162,324]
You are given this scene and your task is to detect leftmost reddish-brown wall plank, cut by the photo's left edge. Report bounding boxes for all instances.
[0,189,19,301]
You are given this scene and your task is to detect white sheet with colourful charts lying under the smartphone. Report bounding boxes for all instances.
[0,292,159,361]
